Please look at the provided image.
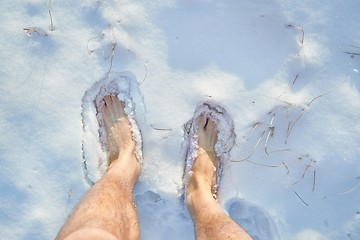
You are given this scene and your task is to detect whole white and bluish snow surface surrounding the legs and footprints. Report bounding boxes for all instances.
[0,0,360,240]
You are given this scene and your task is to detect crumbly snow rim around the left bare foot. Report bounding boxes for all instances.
[82,72,143,185]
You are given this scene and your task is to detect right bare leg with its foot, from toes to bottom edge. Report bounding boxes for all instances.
[186,117,252,240]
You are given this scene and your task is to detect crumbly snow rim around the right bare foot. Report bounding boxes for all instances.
[183,102,236,199]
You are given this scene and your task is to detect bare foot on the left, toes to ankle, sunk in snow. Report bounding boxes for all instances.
[97,95,141,184]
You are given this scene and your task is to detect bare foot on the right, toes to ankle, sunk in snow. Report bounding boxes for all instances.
[186,115,218,204]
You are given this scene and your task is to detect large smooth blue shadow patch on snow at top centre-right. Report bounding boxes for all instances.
[156,0,297,86]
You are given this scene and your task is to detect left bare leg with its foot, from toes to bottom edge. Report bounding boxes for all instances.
[56,96,141,240]
